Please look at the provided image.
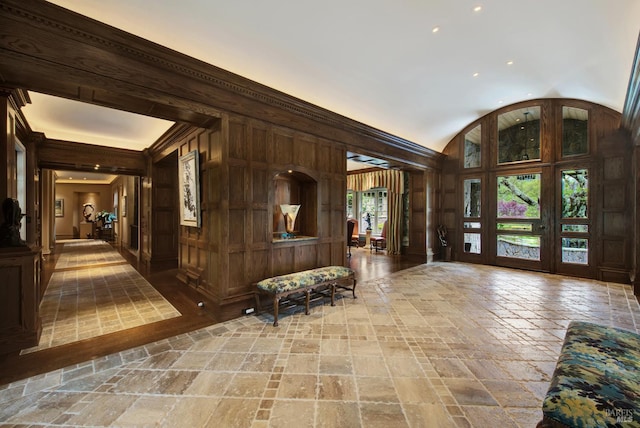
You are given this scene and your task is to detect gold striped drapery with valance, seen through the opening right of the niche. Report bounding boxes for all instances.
[347,170,404,254]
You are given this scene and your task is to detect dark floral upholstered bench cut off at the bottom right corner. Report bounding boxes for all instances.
[538,321,640,428]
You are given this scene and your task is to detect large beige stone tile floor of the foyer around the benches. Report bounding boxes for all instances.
[0,263,640,428]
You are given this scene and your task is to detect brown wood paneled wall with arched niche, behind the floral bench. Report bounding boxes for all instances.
[151,115,346,319]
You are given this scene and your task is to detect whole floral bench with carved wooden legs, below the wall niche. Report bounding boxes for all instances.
[255,266,356,327]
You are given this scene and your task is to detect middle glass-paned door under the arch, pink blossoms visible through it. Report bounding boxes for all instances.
[491,169,553,271]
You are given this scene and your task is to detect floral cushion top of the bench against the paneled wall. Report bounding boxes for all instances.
[256,266,354,294]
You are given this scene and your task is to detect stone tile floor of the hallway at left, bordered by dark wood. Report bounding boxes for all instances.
[21,240,180,354]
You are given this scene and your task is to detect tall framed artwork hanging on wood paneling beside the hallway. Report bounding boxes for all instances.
[178,150,200,227]
